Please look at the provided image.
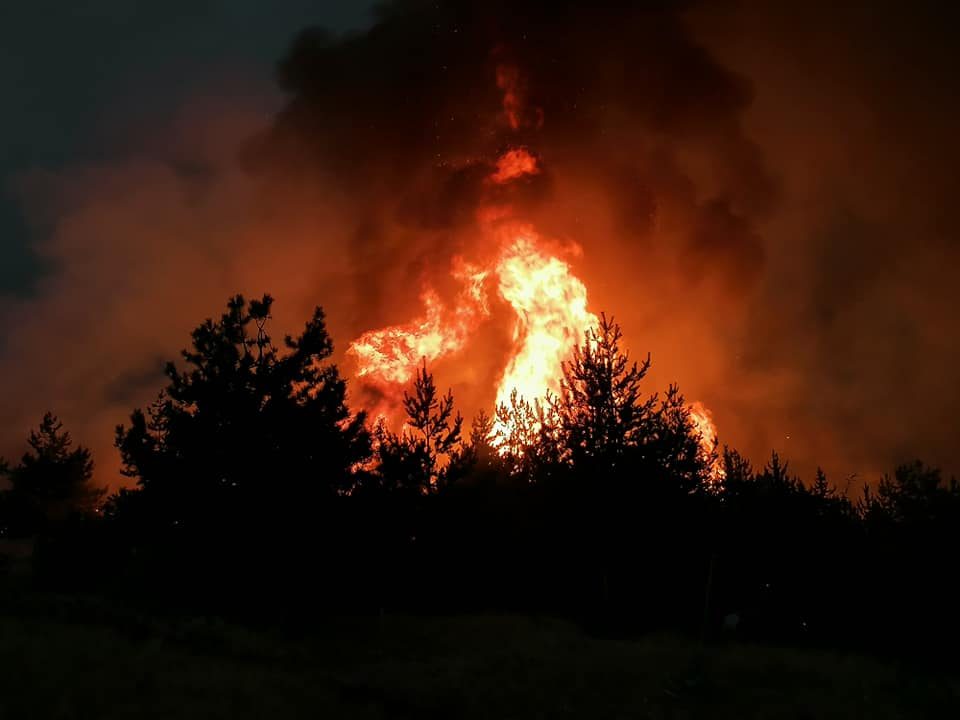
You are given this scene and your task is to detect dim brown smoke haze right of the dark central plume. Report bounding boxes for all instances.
[693,2,960,475]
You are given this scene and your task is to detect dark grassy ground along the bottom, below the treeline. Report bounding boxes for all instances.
[0,600,960,720]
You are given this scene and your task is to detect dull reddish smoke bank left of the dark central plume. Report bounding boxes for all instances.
[0,99,364,485]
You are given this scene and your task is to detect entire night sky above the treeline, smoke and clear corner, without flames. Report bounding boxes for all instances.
[0,0,960,482]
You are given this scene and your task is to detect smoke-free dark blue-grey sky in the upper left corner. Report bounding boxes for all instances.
[0,0,373,295]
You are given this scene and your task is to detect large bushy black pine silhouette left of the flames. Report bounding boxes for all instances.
[111,295,370,527]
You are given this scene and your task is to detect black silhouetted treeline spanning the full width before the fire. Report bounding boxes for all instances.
[0,296,960,651]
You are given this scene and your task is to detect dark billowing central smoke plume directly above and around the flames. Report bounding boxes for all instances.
[248,0,779,456]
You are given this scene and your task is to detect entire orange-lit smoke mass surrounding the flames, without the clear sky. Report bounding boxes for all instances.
[0,0,960,490]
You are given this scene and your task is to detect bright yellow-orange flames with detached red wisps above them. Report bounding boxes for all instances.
[347,65,723,482]
